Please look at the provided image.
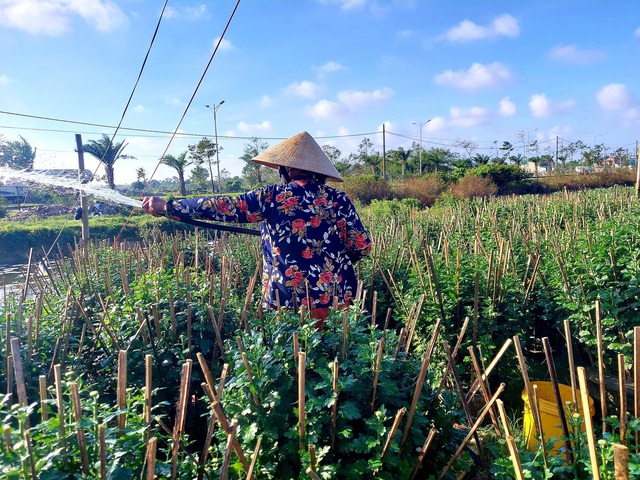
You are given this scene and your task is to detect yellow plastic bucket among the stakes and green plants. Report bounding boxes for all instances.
[522,382,595,454]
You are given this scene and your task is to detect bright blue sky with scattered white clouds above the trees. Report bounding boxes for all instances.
[0,0,640,184]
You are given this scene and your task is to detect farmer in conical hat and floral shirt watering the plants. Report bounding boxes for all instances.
[142,132,371,327]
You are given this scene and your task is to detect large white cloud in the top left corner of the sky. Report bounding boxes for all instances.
[0,0,127,36]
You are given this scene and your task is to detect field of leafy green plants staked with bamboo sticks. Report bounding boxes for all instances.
[0,187,640,480]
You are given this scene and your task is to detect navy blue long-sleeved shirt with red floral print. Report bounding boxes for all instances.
[167,180,371,308]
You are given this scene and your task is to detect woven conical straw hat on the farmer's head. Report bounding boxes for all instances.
[252,132,342,182]
